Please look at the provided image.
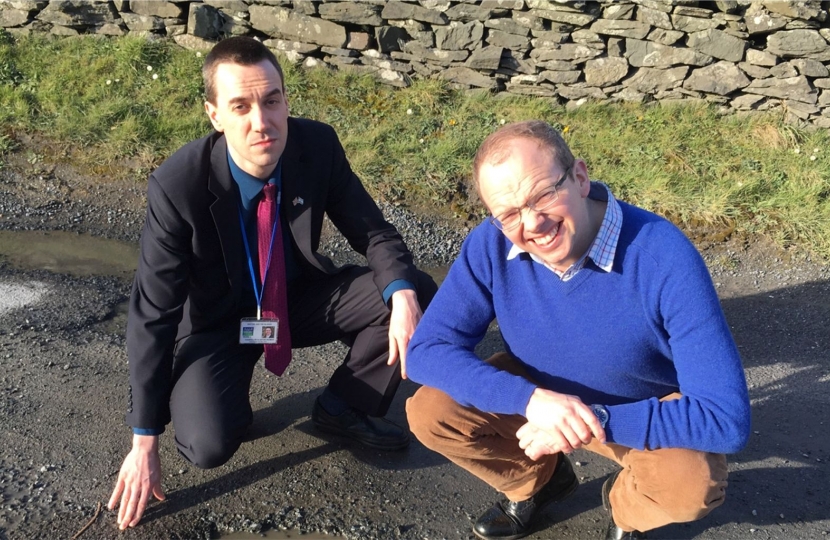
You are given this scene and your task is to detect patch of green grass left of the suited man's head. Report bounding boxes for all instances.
[0,32,208,163]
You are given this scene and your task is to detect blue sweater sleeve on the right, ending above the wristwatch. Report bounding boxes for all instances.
[609,228,750,453]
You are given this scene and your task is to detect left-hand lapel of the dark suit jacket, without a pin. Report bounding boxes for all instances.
[208,137,250,292]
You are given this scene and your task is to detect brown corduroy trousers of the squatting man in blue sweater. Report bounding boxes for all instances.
[406,353,727,531]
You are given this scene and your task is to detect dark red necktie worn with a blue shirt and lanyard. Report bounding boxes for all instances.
[256,184,291,375]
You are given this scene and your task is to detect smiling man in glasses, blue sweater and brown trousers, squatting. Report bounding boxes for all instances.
[407,121,750,539]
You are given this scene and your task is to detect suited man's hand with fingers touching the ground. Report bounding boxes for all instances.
[107,435,164,530]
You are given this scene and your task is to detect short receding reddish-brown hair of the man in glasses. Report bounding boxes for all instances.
[473,120,574,190]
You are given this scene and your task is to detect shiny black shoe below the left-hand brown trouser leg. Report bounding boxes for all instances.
[473,454,579,540]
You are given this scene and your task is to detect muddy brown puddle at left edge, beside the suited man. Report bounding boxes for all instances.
[0,231,138,277]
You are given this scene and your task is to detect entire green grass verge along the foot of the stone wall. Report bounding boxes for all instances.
[0,34,830,259]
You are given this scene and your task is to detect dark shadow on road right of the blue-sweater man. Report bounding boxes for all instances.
[708,281,830,537]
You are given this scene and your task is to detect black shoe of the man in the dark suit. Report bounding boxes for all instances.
[311,398,409,450]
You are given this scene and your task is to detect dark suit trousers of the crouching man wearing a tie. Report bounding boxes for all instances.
[170,267,437,468]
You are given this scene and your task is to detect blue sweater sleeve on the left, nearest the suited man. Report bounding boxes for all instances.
[406,226,535,414]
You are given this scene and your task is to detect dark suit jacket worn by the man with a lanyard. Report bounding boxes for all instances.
[127,118,417,429]
